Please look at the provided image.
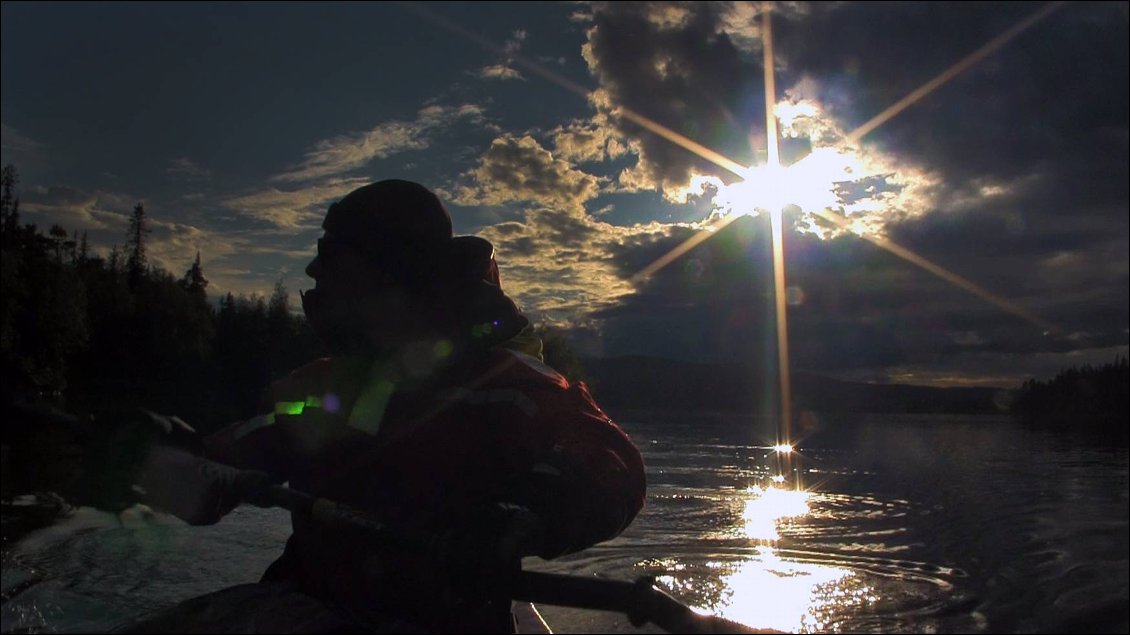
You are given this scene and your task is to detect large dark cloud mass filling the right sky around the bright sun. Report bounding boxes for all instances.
[588,3,1130,384]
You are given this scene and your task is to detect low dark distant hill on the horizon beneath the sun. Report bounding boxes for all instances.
[583,356,1009,414]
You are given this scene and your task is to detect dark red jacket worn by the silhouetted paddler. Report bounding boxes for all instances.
[206,348,645,627]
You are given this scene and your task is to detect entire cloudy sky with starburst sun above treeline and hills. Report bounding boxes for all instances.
[0,1,1130,388]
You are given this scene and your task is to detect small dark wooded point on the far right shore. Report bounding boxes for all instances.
[1012,357,1130,446]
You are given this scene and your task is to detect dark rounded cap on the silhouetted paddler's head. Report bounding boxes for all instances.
[322,180,451,254]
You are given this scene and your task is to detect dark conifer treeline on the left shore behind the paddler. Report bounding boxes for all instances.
[0,165,322,432]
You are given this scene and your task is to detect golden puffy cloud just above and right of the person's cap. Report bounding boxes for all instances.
[451,133,600,215]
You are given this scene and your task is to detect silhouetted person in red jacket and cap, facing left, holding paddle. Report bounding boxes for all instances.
[127,181,645,632]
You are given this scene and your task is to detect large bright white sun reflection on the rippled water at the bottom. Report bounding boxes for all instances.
[659,486,878,633]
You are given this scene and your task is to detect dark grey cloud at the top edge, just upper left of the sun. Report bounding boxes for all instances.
[585,2,765,188]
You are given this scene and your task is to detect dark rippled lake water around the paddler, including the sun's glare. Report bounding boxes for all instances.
[0,416,1130,633]
